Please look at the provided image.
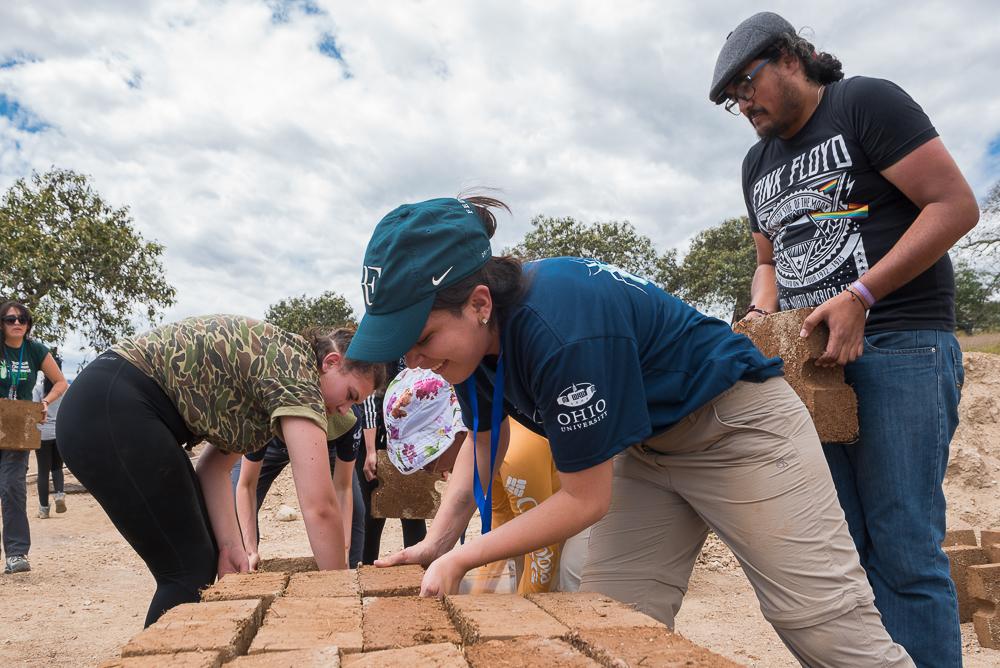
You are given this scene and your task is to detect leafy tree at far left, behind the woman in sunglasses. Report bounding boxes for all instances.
[0,168,175,351]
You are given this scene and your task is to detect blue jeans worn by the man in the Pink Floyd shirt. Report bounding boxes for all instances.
[823,330,965,668]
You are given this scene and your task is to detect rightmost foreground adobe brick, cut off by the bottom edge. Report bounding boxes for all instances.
[569,626,740,668]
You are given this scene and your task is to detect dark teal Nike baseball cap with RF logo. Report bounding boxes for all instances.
[347,197,493,362]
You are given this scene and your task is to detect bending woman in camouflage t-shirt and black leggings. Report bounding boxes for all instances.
[56,315,385,626]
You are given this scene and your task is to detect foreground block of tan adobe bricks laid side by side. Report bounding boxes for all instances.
[103,559,737,668]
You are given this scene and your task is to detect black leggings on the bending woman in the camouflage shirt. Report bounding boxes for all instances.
[56,353,218,626]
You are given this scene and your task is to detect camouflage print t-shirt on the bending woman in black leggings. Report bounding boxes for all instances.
[112,315,327,453]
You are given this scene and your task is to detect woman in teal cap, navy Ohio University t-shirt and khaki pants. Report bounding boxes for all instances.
[347,197,912,666]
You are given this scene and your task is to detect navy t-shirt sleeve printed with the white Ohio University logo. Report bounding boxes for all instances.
[532,337,652,473]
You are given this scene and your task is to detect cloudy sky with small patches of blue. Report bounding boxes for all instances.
[0,0,1000,370]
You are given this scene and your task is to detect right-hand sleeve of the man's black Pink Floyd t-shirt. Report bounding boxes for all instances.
[843,77,938,171]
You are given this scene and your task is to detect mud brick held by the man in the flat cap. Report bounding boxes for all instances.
[733,308,858,443]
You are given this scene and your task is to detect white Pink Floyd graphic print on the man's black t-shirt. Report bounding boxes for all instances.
[751,134,868,311]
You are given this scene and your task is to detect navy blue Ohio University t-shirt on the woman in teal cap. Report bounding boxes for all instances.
[457,258,782,472]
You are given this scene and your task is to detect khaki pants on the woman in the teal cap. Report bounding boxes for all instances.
[580,378,913,668]
